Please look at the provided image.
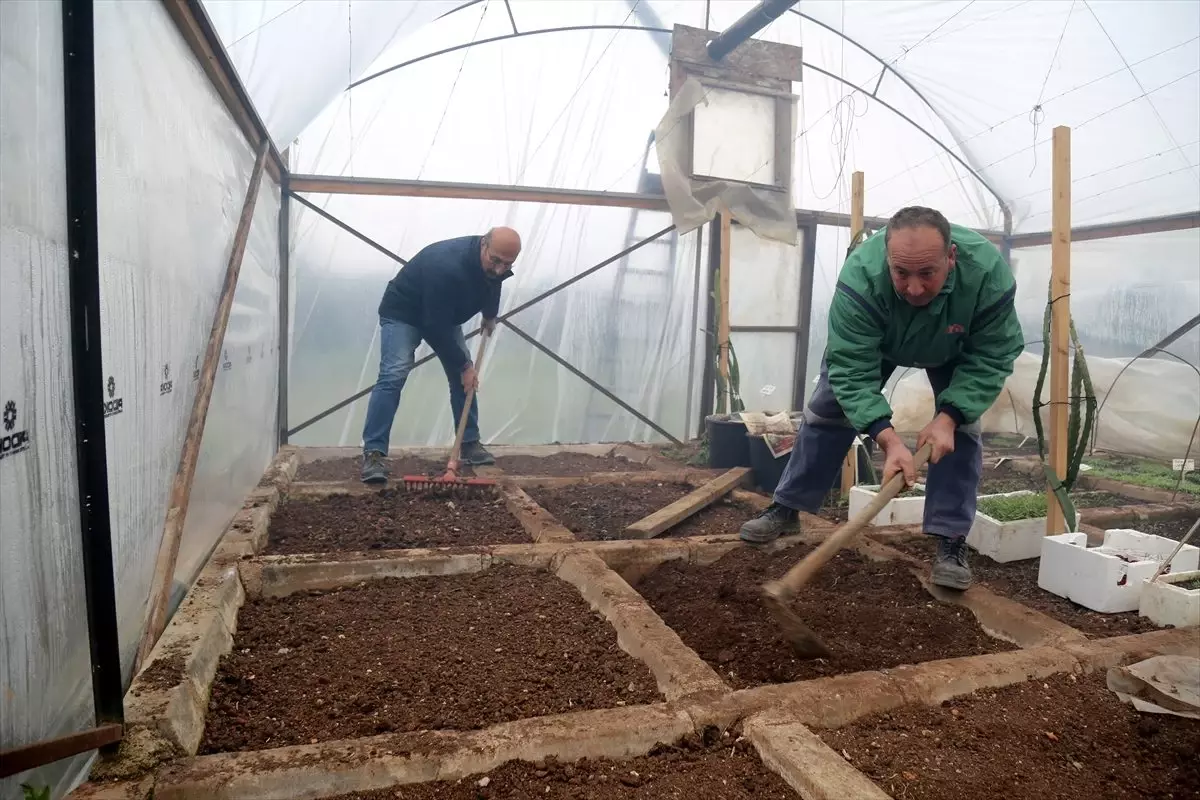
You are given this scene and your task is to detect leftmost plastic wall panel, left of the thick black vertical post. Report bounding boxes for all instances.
[0,2,95,800]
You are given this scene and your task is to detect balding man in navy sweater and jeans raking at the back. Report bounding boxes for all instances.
[362,228,521,483]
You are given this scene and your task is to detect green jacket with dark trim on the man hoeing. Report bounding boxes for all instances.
[826,225,1025,438]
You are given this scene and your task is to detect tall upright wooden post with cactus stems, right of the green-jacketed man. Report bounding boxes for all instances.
[1043,126,1070,536]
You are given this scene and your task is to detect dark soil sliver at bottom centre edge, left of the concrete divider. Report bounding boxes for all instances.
[331,728,797,800]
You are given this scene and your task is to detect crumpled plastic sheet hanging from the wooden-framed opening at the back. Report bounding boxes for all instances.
[654,78,797,245]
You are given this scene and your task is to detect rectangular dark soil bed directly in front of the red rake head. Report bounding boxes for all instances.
[265,489,530,555]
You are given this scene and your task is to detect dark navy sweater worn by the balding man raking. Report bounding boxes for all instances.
[379,236,512,369]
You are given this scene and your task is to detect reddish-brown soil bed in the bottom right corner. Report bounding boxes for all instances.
[821,673,1200,800]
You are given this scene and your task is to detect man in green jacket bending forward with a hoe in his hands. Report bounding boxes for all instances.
[742,206,1024,589]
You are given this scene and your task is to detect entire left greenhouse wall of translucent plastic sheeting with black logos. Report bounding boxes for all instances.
[0,1,280,800]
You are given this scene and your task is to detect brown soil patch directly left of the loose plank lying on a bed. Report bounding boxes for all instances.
[526,483,692,541]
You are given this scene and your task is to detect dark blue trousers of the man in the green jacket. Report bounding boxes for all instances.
[774,360,983,539]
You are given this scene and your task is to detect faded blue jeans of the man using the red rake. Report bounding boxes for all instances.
[362,317,479,455]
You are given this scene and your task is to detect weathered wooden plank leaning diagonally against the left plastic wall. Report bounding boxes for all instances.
[133,139,270,674]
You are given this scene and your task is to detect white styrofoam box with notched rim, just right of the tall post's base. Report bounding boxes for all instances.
[1038,528,1200,614]
